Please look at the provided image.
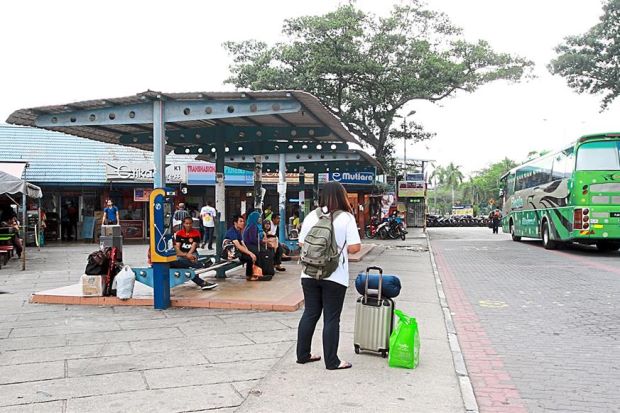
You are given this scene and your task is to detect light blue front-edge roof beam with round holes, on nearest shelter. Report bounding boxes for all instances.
[35,99,301,127]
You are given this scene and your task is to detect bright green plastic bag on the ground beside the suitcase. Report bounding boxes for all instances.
[388,310,420,369]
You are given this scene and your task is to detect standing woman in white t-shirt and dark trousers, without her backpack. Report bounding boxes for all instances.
[297,182,362,370]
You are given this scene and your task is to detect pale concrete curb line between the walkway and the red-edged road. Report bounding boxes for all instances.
[426,232,480,413]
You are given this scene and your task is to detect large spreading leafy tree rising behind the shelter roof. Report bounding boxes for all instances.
[225,0,532,164]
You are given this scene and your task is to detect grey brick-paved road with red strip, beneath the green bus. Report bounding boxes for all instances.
[429,228,620,412]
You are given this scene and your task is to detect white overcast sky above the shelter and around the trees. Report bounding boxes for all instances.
[0,0,620,173]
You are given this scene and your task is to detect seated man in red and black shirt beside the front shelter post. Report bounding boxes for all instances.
[170,216,217,290]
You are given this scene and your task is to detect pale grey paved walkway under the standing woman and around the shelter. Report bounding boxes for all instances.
[0,233,463,412]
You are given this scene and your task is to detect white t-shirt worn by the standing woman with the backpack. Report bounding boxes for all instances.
[299,211,361,287]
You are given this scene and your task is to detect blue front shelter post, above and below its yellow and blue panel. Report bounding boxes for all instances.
[151,100,170,310]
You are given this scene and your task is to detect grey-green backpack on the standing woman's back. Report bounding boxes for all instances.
[300,208,346,280]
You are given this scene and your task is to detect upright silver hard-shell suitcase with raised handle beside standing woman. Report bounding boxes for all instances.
[353,267,394,358]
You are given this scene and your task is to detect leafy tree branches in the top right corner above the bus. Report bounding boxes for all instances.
[549,0,620,109]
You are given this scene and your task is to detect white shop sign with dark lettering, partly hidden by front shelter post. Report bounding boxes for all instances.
[105,162,187,183]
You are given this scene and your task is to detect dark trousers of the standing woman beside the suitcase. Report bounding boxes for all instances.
[297,278,347,369]
